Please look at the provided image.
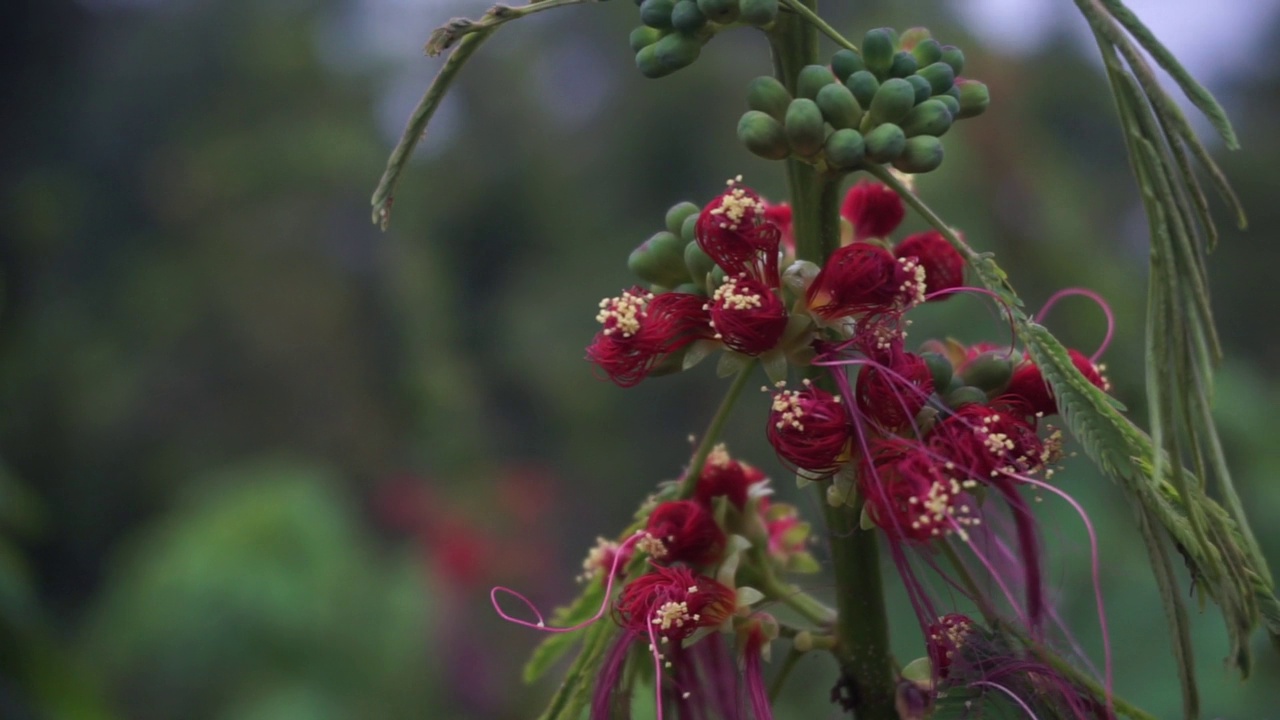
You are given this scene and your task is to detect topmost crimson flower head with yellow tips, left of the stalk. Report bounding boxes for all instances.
[694,181,782,287]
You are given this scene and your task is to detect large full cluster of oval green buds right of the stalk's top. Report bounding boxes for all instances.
[737,28,989,173]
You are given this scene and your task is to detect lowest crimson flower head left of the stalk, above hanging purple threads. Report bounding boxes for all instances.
[613,565,737,641]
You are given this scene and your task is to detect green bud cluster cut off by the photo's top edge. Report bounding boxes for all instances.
[631,0,778,78]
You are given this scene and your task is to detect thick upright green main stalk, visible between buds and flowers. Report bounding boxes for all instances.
[772,7,897,720]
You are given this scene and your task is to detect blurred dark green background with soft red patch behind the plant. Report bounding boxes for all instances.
[0,0,1280,720]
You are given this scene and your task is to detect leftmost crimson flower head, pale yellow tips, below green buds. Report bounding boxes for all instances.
[586,286,709,387]
